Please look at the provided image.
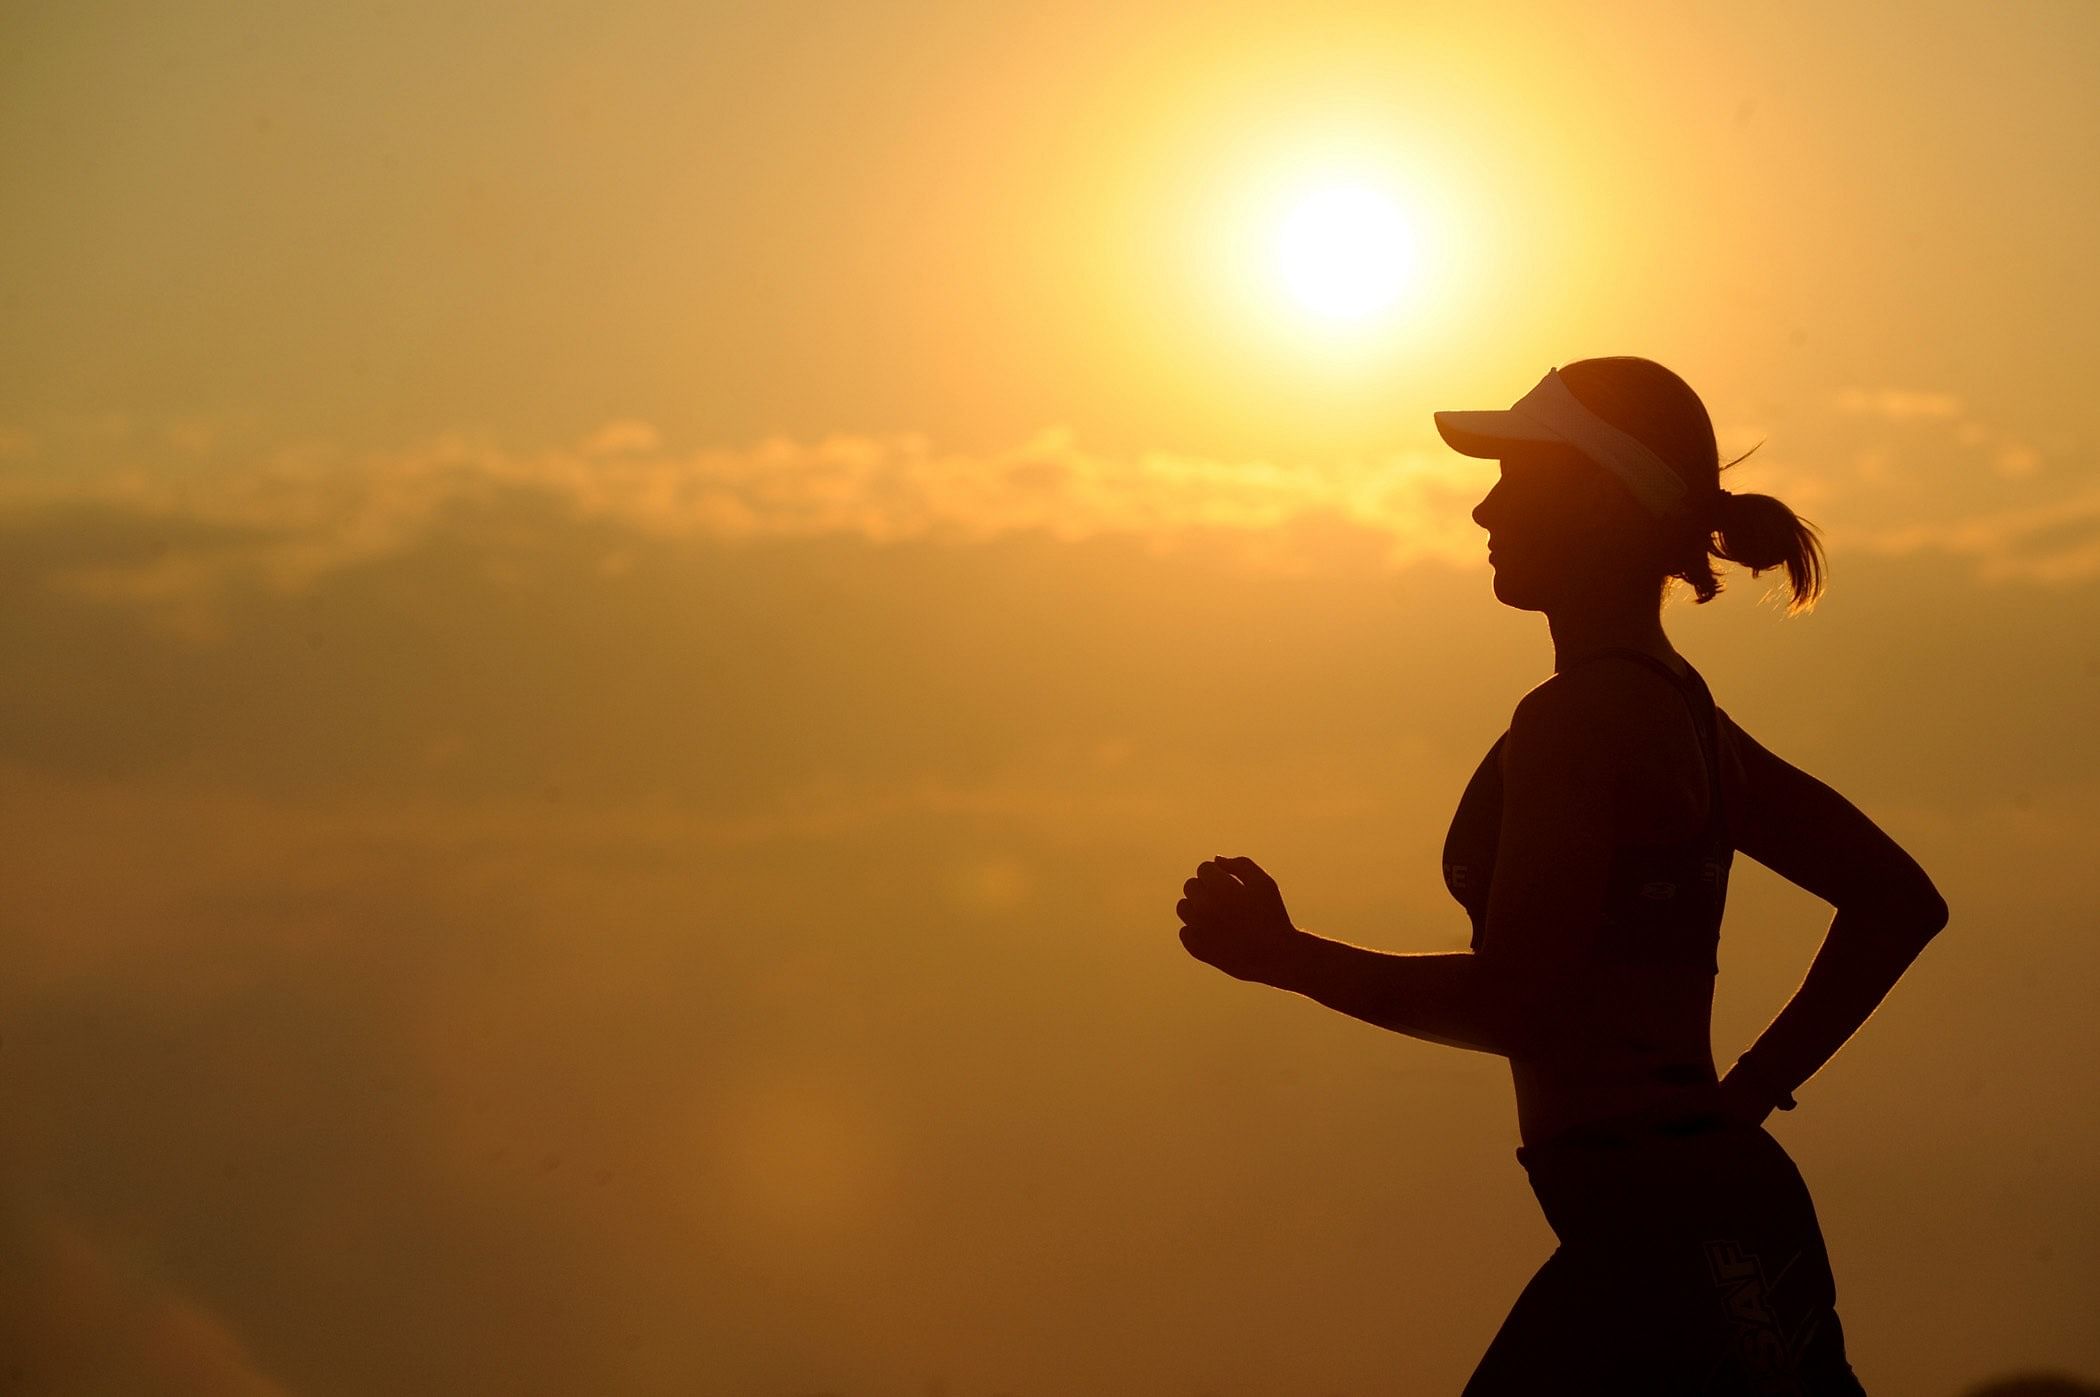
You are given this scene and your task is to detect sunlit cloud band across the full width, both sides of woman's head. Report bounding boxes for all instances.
[0,403,2100,645]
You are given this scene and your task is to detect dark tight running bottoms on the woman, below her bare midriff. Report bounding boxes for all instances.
[1466,1115,1867,1397]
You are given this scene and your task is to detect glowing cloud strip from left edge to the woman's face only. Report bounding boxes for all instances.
[0,420,1487,617]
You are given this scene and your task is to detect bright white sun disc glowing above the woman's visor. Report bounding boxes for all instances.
[1277,185,1415,321]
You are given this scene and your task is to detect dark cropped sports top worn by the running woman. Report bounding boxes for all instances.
[1443,647,1735,975]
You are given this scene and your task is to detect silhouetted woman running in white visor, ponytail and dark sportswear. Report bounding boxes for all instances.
[1176,357,1947,1397]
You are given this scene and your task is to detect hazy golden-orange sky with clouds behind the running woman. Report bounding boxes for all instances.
[0,0,2100,1397]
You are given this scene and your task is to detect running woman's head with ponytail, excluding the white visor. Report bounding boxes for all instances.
[1472,355,1825,616]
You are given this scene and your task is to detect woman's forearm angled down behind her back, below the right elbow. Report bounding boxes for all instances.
[1728,905,1947,1105]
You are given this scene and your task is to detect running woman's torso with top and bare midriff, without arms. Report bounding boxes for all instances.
[1445,655,1743,1145]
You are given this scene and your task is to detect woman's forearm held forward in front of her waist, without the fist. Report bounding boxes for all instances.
[1260,931,1523,1057]
